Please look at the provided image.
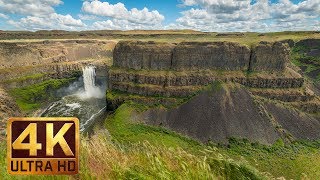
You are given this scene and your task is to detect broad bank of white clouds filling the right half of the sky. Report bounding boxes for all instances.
[176,0,320,31]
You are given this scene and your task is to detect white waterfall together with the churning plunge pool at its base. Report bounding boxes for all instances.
[40,66,106,131]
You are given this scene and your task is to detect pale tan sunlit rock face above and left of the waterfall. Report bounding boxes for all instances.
[0,41,115,69]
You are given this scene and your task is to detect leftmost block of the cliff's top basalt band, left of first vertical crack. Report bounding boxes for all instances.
[113,41,175,70]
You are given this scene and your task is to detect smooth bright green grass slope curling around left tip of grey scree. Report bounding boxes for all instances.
[105,103,200,149]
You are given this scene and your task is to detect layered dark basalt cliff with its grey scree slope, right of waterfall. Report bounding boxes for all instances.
[107,41,320,143]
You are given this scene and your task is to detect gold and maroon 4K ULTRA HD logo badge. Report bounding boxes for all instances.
[7,117,79,175]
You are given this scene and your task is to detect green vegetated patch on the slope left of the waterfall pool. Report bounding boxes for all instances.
[9,78,76,112]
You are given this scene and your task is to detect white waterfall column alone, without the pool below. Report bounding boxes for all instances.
[79,65,103,98]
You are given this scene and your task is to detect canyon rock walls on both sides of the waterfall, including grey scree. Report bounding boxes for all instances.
[0,35,320,143]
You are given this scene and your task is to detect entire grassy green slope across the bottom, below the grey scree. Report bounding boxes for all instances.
[0,103,320,179]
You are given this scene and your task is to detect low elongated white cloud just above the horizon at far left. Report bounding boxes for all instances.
[8,13,86,30]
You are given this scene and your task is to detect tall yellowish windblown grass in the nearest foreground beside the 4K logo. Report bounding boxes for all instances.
[0,131,262,179]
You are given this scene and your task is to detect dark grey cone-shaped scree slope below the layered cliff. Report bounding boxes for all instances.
[141,83,320,144]
